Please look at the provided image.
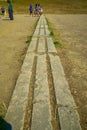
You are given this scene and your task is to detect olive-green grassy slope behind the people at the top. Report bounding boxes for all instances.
[0,0,87,14]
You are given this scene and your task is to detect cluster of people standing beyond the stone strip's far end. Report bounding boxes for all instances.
[29,4,43,16]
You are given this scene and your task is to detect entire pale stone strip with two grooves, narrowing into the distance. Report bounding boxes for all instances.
[6,15,81,130]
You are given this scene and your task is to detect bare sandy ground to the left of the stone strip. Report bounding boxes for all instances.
[0,15,37,115]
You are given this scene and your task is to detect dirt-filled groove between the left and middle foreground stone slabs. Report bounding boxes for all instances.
[23,56,37,130]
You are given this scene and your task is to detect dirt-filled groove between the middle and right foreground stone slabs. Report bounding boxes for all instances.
[46,55,60,130]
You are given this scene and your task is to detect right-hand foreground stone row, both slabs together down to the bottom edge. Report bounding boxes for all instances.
[50,55,81,130]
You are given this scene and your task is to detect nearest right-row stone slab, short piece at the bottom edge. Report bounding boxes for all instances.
[58,107,82,130]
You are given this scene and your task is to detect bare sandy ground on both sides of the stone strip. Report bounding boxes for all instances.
[0,14,87,130]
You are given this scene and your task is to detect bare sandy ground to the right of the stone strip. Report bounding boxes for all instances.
[46,15,87,130]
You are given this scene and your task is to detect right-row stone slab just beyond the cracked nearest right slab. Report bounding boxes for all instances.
[50,55,76,107]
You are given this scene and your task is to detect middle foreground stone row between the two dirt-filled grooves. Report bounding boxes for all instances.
[31,55,52,130]
